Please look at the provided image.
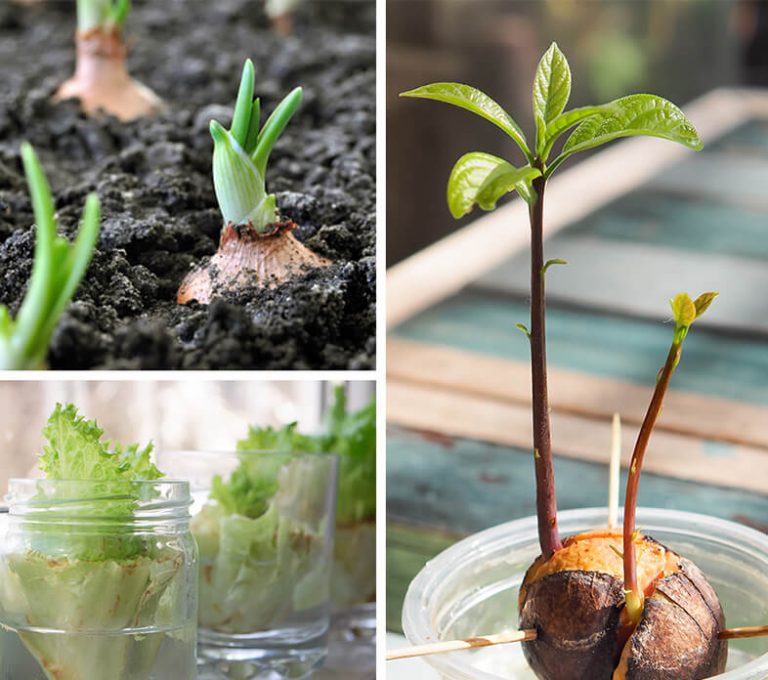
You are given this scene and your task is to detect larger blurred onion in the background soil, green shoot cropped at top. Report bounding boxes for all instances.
[54,0,163,121]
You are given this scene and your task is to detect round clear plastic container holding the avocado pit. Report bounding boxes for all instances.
[403,508,768,680]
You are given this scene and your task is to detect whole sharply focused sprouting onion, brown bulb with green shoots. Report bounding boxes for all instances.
[176,59,330,304]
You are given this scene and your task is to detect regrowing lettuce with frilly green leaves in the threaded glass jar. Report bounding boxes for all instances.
[0,404,193,680]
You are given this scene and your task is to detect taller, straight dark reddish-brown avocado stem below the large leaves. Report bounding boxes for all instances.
[530,177,563,560]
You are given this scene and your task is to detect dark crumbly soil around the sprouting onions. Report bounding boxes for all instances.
[0,0,376,369]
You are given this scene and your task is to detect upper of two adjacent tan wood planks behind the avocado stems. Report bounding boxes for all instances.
[387,337,768,449]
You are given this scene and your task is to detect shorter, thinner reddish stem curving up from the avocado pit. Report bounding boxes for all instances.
[624,340,683,623]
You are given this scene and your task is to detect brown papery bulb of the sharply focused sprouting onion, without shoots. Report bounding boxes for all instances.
[176,220,331,305]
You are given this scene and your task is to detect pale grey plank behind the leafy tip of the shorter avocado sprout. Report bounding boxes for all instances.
[476,238,768,339]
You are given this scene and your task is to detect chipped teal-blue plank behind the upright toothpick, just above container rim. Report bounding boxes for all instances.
[387,428,768,534]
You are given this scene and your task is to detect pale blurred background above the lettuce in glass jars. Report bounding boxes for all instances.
[0,379,375,495]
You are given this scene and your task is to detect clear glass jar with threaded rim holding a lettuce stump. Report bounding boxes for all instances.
[0,479,198,680]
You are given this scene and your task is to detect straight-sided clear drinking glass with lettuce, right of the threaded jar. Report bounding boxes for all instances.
[161,451,337,680]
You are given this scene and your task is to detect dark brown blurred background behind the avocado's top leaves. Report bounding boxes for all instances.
[387,0,768,266]
